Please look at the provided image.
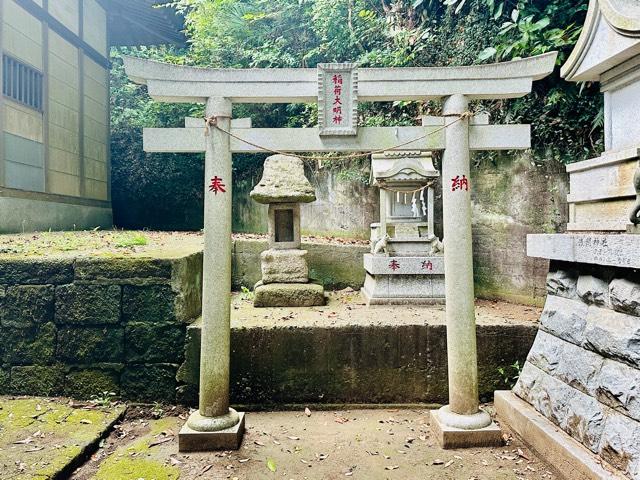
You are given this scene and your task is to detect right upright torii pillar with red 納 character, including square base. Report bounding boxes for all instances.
[431,95,501,448]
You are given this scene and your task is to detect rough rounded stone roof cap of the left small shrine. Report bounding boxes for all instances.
[250,155,316,203]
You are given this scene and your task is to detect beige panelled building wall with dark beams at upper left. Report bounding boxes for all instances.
[0,0,112,233]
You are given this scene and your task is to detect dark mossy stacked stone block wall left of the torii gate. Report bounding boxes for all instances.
[0,253,202,402]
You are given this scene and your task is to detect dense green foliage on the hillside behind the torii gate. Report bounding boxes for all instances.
[111,0,603,229]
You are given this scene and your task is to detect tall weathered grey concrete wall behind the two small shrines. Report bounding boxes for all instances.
[234,154,568,305]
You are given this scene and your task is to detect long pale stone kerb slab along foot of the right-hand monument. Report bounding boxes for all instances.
[494,391,626,480]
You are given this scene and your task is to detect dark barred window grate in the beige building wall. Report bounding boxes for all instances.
[2,55,43,112]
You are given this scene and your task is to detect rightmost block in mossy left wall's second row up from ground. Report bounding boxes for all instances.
[125,322,185,363]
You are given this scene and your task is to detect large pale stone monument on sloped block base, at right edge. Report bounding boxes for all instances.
[496,0,640,480]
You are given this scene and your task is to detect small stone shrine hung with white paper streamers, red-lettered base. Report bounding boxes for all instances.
[362,151,445,305]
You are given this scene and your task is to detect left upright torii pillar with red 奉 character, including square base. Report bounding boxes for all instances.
[179,97,244,452]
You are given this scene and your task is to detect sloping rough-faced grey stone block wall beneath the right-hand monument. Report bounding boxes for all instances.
[514,262,640,480]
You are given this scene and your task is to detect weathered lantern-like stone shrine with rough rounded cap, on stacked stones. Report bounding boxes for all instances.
[250,155,325,307]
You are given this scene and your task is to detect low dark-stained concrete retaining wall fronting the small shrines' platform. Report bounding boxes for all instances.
[178,316,537,407]
